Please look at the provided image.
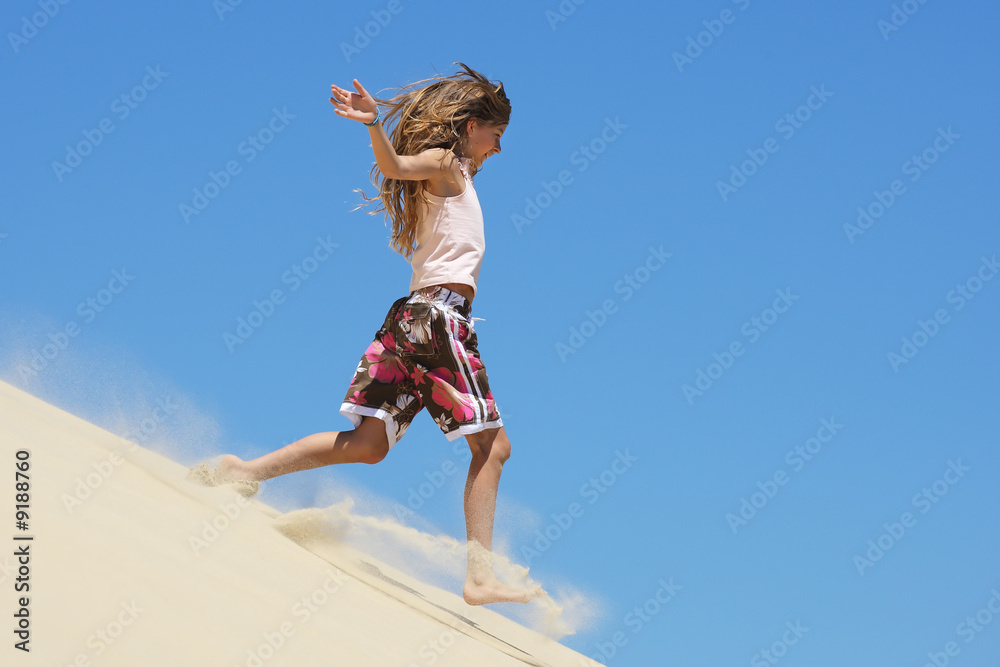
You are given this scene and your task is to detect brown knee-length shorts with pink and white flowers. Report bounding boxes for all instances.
[340,286,503,447]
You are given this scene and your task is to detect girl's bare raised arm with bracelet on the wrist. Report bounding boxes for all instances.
[330,79,462,184]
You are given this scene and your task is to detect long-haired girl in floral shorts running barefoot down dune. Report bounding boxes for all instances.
[191,63,542,605]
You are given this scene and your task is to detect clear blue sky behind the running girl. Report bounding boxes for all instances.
[0,0,1000,667]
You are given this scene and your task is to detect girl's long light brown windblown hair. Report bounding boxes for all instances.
[359,63,510,258]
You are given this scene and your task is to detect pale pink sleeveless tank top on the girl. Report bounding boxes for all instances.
[410,157,486,295]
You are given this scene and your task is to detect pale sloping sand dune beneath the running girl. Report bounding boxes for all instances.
[0,382,597,667]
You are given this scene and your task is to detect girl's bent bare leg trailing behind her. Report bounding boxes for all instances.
[213,417,389,482]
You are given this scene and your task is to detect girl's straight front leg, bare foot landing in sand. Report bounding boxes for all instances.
[462,426,543,605]
